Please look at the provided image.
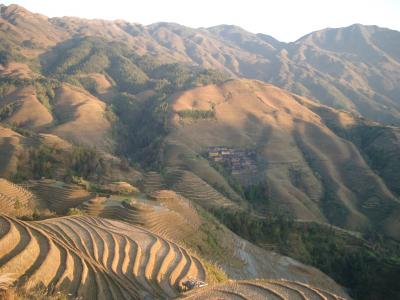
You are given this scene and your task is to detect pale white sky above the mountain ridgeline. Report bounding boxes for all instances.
[2,0,400,42]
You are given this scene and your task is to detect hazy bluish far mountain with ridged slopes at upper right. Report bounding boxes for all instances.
[210,24,400,125]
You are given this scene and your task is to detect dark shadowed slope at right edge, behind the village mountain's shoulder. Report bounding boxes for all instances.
[297,98,400,238]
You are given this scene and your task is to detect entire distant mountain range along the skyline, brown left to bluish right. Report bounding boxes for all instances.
[1,5,400,125]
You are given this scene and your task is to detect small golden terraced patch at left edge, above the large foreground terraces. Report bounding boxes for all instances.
[0,178,36,216]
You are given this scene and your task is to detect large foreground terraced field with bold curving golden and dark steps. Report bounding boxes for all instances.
[0,215,206,299]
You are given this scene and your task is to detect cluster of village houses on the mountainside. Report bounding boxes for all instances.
[208,146,257,175]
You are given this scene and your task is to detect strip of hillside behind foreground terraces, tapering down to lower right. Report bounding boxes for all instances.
[4,179,343,294]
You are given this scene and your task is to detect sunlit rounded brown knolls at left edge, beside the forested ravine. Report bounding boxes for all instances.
[0,63,113,150]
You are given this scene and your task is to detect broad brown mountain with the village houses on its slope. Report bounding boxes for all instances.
[163,80,400,238]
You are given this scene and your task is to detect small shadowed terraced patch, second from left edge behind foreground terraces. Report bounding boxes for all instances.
[29,179,93,214]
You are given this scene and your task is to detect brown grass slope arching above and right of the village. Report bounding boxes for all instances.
[164,80,398,237]
